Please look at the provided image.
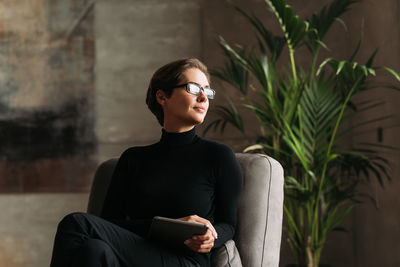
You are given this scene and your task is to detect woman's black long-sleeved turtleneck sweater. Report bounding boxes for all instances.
[101,128,242,266]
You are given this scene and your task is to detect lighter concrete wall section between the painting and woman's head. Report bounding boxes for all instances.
[95,0,202,159]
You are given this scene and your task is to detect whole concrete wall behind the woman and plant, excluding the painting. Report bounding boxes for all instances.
[0,0,400,267]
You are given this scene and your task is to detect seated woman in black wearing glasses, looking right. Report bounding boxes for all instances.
[51,58,242,267]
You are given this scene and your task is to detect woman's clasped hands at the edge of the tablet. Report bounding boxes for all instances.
[179,215,218,253]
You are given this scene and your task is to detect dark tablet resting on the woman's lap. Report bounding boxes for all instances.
[149,216,208,244]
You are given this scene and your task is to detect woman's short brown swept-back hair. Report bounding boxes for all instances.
[146,58,210,126]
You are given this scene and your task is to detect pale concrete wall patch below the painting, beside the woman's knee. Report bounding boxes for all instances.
[0,193,88,267]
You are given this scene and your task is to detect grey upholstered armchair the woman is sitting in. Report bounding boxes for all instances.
[88,153,283,267]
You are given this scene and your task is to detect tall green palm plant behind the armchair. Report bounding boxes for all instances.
[205,0,400,267]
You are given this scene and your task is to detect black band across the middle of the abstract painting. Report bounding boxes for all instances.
[0,100,95,161]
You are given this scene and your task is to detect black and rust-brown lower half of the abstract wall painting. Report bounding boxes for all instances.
[0,100,96,193]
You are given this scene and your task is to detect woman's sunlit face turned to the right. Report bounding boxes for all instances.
[157,68,210,132]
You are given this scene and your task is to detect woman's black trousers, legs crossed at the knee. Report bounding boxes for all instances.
[50,213,200,267]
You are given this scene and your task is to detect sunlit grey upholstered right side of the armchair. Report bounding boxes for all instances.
[235,153,283,267]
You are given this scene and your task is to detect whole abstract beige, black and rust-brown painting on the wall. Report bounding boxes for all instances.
[0,0,96,192]
